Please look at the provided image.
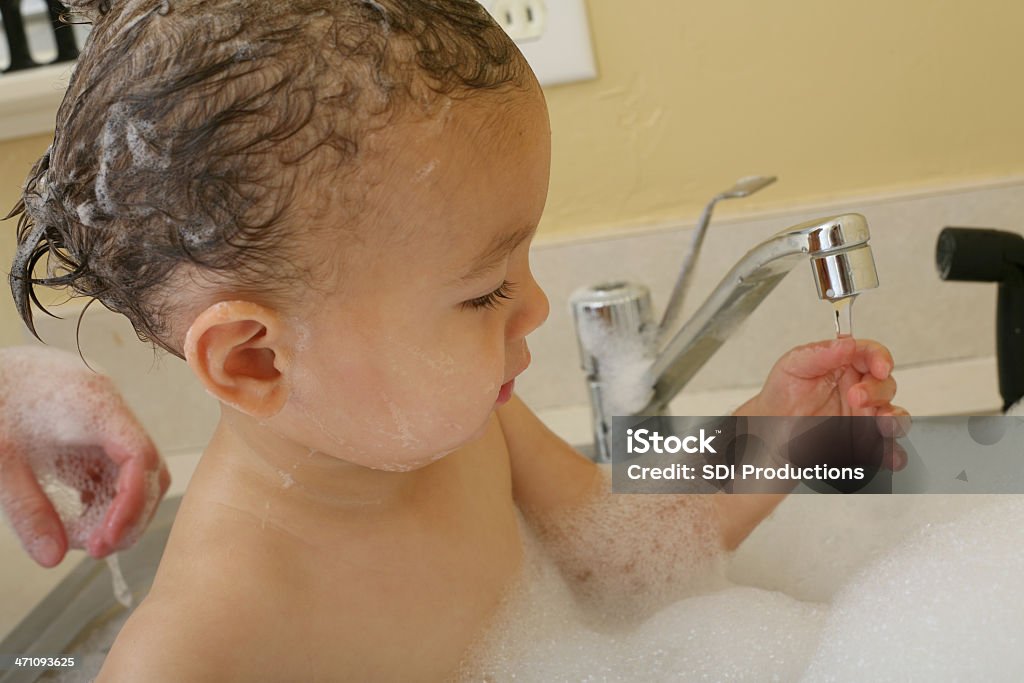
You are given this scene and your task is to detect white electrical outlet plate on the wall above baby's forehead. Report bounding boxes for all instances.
[483,0,597,86]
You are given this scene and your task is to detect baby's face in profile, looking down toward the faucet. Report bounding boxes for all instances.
[283,90,550,471]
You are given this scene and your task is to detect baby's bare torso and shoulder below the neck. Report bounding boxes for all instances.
[99,420,522,681]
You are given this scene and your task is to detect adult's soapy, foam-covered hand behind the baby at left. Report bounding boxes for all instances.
[0,347,170,566]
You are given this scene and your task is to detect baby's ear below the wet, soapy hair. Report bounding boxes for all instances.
[184,301,290,418]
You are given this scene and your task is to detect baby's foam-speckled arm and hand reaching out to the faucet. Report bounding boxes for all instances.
[498,339,906,613]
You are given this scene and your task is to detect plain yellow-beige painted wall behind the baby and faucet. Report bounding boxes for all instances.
[0,0,1024,335]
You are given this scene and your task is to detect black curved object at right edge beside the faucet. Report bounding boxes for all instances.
[935,227,1024,412]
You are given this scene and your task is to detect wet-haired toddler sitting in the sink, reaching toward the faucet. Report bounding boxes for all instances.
[11,0,902,682]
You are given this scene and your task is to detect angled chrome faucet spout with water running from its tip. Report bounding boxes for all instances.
[638,213,879,415]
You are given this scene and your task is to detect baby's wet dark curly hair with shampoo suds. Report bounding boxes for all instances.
[8,0,532,356]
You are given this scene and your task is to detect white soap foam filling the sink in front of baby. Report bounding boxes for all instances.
[462,496,1024,683]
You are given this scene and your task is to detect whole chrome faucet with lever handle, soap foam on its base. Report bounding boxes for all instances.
[570,185,879,462]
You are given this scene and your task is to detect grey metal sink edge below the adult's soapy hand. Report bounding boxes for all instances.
[0,496,181,683]
